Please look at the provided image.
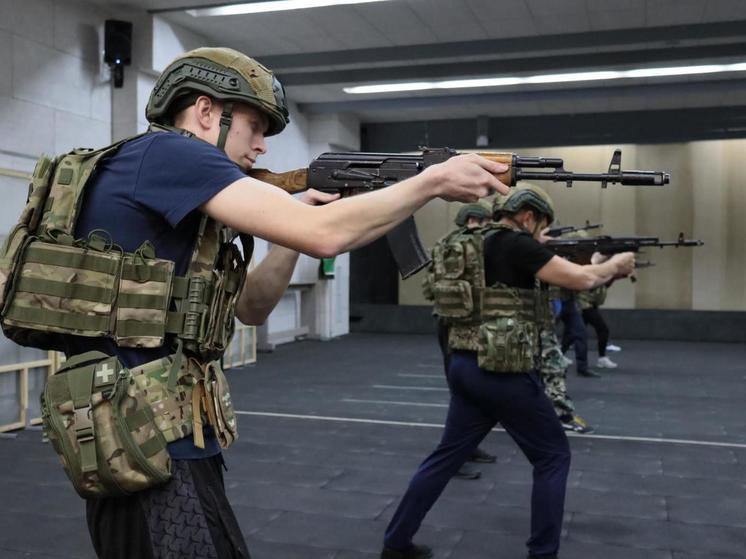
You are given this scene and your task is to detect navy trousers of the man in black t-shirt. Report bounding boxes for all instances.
[384,351,570,555]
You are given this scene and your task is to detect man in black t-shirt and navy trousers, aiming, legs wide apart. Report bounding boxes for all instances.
[381,186,634,559]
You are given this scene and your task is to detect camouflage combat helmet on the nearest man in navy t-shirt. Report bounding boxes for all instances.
[145,47,290,149]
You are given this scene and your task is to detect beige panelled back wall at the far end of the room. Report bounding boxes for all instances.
[399,140,746,310]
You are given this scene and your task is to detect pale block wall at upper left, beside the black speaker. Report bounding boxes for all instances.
[0,0,111,177]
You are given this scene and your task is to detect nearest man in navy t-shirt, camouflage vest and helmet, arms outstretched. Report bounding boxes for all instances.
[0,48,508,559]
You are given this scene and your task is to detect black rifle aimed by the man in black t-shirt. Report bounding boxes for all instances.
[544,233,704,267]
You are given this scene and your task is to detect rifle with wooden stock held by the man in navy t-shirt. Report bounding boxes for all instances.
[249,148,670,278]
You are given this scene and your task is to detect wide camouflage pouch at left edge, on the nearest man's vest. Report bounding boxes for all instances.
[3,240,121,337]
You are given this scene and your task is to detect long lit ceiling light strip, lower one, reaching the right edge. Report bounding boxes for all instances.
[344,62,746,95]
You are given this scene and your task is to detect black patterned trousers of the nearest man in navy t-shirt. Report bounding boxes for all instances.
[86,456,250,559]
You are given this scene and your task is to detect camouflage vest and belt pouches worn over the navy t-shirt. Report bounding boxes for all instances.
[0,126,247,497]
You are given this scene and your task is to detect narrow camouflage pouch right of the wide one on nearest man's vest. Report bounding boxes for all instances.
[114,244,174,348]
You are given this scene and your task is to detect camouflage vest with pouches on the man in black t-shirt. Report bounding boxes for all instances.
[424,223,548,373]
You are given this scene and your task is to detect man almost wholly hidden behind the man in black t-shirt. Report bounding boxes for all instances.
[423,204,496,480]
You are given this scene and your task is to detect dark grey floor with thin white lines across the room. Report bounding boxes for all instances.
[0,334,746,559]
